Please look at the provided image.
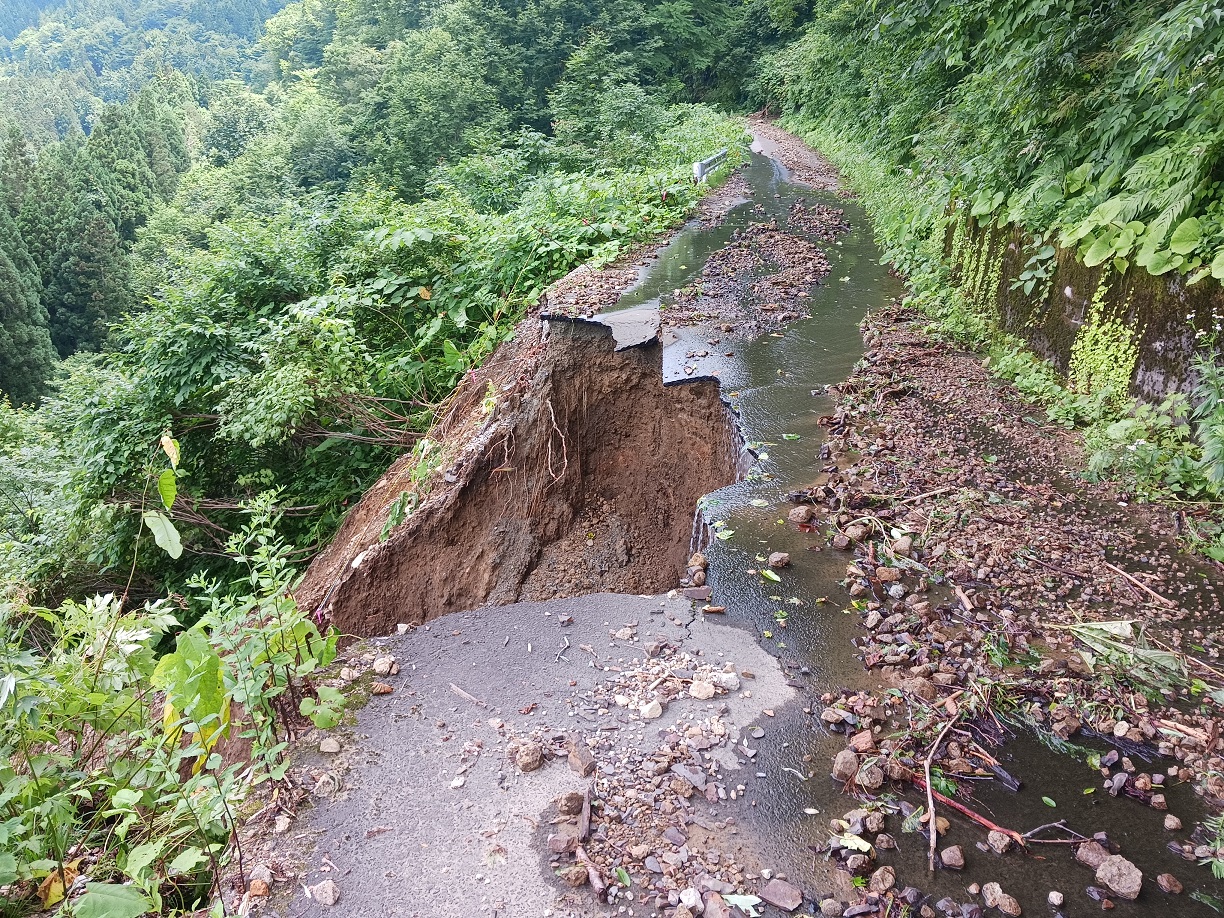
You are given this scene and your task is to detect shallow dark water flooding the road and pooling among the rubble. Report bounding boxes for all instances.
[603,141,1224,916]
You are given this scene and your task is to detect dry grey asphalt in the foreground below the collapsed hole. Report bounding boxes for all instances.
[273,595,793,918]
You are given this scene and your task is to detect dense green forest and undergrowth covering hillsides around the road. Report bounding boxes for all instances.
[0,0,1224,916]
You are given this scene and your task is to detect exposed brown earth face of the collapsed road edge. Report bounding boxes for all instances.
[297,318,739,634]
